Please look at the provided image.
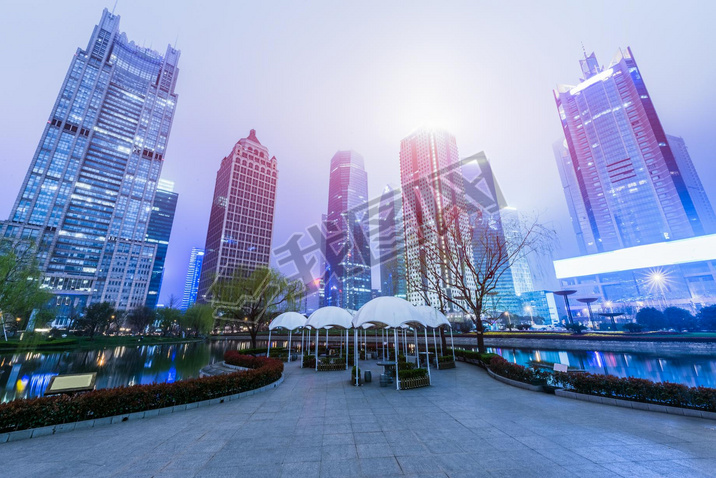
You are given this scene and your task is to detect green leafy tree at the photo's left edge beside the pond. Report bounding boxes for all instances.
[0,239,52,320]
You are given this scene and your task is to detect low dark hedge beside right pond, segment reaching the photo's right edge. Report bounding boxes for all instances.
[553,372,716,412]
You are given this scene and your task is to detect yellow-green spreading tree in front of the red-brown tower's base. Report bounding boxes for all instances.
[209,267,305,348]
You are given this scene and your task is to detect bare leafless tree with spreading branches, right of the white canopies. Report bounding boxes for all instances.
[419,206,555,353]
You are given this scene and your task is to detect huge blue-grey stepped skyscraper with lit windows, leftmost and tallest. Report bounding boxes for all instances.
[2,9,179,326]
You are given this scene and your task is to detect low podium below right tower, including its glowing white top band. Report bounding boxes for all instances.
[554,234,716,309]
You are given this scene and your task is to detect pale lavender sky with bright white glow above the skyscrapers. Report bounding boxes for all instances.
[0,0,716,302]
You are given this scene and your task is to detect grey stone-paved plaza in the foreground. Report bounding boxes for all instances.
[0,362,716,478]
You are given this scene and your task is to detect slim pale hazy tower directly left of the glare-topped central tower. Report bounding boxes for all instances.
[378,185,407,299]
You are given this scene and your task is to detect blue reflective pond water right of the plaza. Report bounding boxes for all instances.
[488,347,716,388]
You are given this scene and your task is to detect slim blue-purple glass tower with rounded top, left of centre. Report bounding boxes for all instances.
[323,151,371,310]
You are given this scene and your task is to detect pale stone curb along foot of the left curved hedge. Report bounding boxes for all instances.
[0,374,283,443]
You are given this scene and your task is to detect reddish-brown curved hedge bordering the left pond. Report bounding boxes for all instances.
[0,352,283,433]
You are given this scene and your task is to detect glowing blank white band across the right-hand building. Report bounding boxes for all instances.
[554,234,716,279]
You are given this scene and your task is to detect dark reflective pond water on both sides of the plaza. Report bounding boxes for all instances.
[0,340,716,401]
